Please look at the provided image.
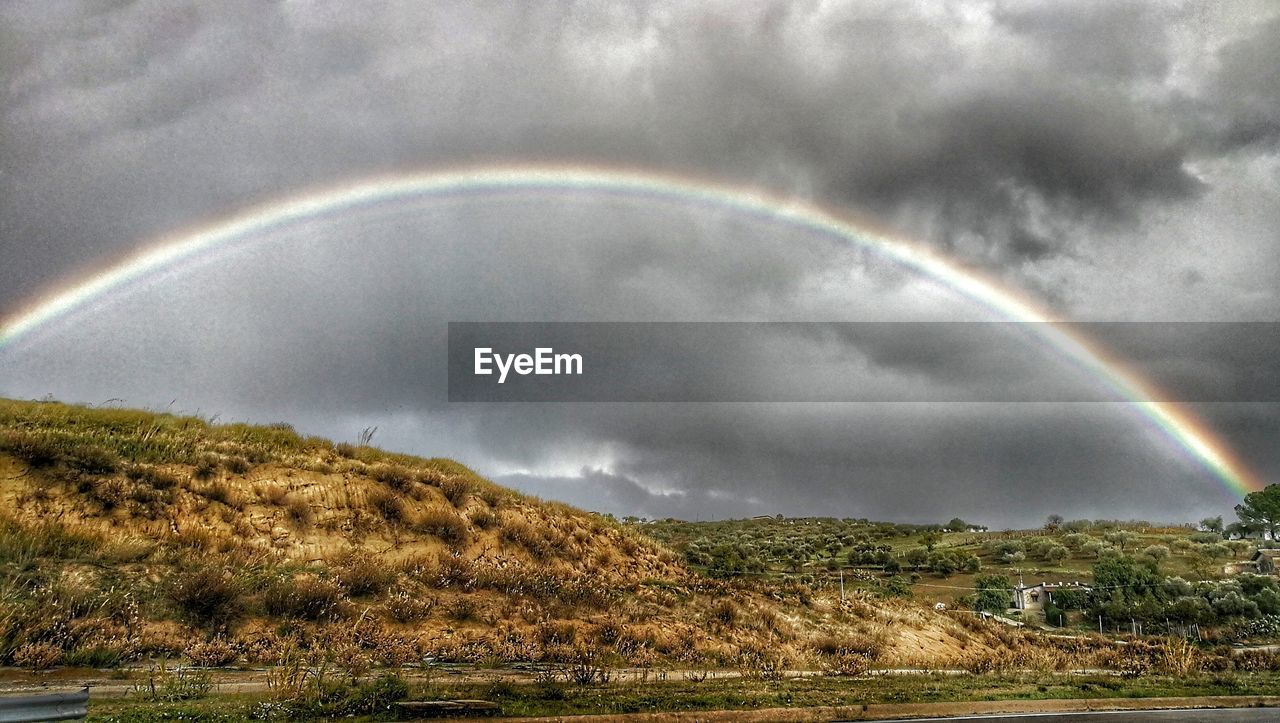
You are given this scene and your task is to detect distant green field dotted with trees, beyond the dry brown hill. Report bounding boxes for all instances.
[640,518,1257,618]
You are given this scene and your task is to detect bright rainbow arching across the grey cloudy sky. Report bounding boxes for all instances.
[0,165,1262,495]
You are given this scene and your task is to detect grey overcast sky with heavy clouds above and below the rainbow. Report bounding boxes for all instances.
[0,0,1280,525]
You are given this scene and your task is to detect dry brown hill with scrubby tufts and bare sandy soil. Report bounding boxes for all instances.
[0,401,1006,676]
